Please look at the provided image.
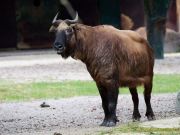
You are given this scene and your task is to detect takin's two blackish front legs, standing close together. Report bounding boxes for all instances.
[98,86,119,127]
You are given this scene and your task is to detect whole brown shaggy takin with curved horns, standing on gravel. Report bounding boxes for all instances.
[49,14,155,127]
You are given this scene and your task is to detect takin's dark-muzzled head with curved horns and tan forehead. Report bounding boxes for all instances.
[49,13,78,57]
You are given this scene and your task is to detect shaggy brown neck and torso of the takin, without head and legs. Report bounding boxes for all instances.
[67,24,154,87]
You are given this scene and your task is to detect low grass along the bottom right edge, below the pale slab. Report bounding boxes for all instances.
[99,123,180,135]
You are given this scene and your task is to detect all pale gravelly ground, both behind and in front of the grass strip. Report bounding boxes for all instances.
[0,50,180,135]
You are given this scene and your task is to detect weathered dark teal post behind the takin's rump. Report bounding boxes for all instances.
[144,0,170,59]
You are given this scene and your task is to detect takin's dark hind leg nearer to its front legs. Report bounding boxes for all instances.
[129,88,141,121]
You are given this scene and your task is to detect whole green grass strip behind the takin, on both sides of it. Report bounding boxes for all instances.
[0,75,180,101]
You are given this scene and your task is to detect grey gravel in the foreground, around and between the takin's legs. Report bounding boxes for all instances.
[0,94,178,135]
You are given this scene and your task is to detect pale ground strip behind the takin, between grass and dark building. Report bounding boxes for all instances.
[0,49,180,82]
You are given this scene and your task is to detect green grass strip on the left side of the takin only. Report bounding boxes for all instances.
[0,81,98,101]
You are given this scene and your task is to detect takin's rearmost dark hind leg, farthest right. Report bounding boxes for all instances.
[144,83,155,120]
